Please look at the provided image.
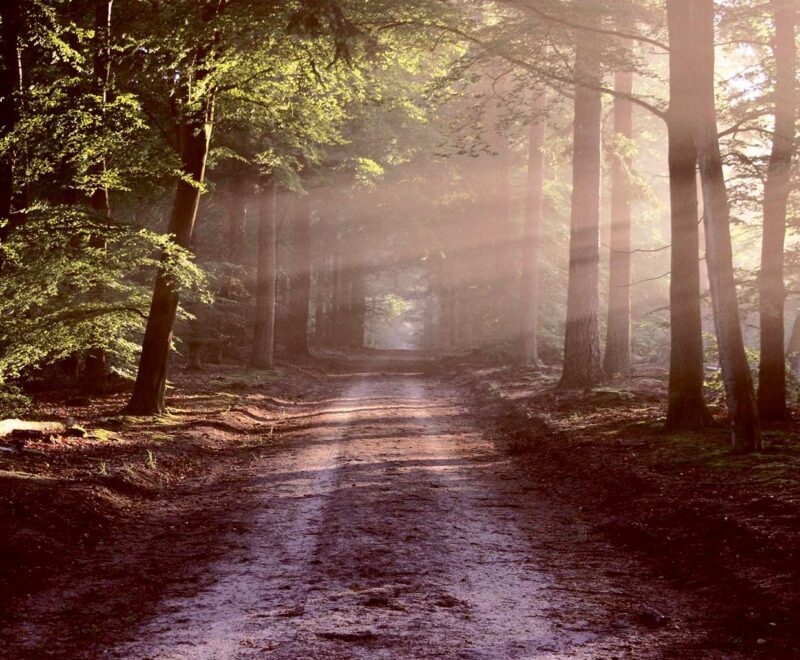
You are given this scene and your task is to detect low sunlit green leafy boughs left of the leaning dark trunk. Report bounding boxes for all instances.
[0,204,206,382]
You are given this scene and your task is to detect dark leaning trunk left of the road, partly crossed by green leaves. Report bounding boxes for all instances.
[126,114,213,415]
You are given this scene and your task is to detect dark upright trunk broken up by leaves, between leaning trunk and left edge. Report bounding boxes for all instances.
[85,0,114,393]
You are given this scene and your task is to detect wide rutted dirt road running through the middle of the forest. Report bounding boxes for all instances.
[0,374,732,659]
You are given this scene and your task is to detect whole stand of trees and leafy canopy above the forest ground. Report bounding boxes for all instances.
[0,0,797,451]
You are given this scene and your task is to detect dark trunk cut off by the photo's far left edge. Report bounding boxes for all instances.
[0,0,21,266]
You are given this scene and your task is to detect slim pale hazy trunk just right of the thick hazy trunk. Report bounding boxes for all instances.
[603,71,633,376]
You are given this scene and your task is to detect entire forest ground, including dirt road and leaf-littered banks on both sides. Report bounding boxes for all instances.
[0,354,800,659]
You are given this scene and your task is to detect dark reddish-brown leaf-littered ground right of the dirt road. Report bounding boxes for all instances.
[453,367,800,658]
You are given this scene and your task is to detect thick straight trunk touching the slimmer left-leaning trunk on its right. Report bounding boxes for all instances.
[666,0,710,431]
